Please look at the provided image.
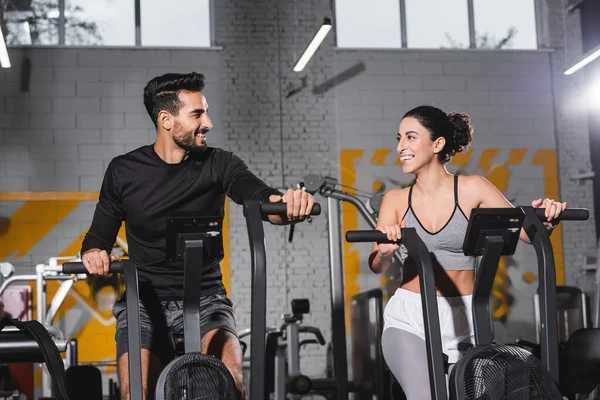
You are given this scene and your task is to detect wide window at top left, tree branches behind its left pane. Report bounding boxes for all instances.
[0,0,211,47]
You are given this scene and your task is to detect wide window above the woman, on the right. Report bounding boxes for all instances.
[335,0,537,49]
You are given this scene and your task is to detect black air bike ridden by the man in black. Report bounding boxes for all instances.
[63,201,321,400]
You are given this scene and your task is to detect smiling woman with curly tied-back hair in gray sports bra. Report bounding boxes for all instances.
[369,106,566,399]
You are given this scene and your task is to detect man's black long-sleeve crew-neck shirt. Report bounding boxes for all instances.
[81,145,281,300]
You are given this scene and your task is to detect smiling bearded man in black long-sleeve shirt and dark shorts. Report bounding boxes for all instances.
[81,73,314,400]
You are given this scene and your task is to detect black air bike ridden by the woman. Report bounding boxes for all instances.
[346,206,589,400]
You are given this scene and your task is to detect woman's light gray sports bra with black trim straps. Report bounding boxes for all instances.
[400,175,477,271]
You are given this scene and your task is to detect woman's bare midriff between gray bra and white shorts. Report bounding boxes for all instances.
[400,270,475,297]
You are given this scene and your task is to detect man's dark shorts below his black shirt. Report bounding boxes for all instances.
[113,294,237,365]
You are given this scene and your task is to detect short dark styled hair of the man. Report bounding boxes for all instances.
[144,72,204,126]
